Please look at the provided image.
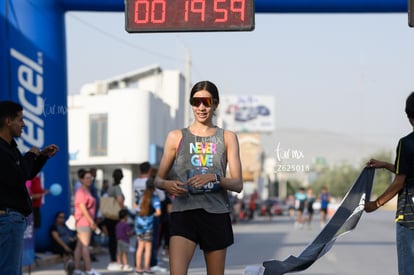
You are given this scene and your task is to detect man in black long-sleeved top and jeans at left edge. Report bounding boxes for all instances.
[0,101,59,275]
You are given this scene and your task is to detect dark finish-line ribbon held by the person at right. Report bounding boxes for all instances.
[263,168,375,275]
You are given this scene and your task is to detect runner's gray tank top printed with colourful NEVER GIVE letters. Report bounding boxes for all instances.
[172,128,231,214]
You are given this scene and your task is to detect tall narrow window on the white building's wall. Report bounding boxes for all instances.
[89,114,108,157]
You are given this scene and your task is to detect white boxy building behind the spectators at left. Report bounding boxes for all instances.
[68,65,188,206]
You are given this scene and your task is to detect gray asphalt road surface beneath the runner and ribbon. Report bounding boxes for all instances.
[26,210,397,275]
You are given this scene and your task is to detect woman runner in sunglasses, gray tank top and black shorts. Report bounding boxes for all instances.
[155,81,243,275]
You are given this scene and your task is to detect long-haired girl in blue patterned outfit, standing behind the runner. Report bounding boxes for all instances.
[135,178,161,274]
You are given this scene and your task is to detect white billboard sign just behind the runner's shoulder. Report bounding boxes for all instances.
[219,95,275,132]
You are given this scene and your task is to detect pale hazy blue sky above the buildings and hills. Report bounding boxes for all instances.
[66,12,414,150]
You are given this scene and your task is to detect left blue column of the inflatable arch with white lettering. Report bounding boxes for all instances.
[0,0,70,251]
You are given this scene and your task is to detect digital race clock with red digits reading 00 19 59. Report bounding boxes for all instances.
[125,0,254,33]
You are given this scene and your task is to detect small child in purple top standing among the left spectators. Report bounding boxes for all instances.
[115,209,133,271]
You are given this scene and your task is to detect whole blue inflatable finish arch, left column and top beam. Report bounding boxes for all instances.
[0,0,407,254]
